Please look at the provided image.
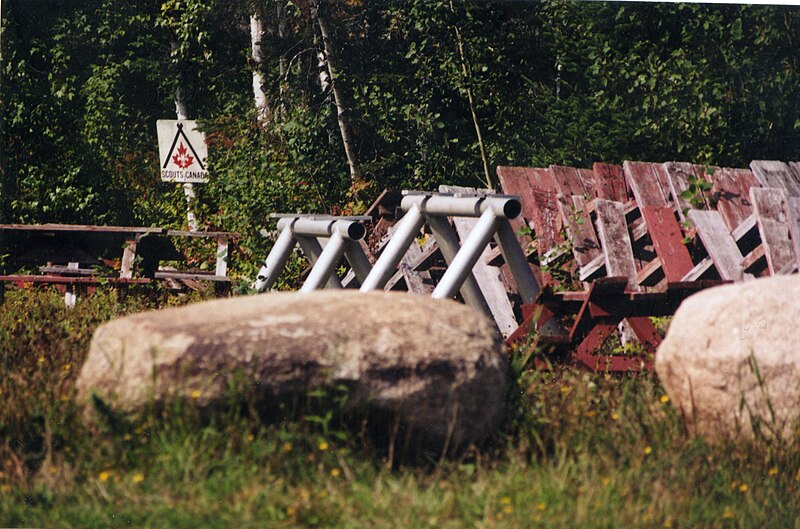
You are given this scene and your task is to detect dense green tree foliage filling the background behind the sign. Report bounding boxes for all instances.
[0,0,800,282]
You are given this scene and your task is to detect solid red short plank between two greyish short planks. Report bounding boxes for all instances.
[641,206,694,282]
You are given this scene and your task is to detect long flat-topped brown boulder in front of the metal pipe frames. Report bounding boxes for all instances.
[77,290,507,449]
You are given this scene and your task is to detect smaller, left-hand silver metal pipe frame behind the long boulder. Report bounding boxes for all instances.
[252,217,371,292]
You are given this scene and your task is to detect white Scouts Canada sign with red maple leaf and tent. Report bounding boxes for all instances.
[156,119,208,183]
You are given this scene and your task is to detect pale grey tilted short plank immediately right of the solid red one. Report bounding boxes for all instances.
[688,209,743,281]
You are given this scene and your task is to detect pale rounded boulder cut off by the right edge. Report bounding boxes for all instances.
[656,275,800,439]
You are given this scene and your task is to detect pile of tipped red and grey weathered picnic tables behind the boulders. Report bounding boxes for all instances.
[366,161,800,370]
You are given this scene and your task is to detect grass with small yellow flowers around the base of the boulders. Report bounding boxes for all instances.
[0,290,800,528]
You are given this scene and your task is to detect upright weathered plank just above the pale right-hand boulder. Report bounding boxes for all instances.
[750,187,794,275]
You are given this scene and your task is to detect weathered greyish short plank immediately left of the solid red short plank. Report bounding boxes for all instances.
[595,199,639,290]
